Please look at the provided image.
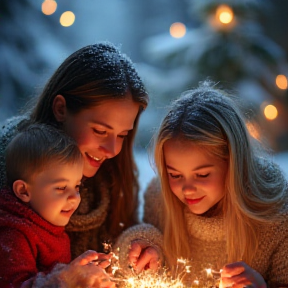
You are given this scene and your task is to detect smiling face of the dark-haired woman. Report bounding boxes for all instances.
[57,97,140,177]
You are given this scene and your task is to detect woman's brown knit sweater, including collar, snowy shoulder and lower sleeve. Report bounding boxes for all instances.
[0,115,121,288]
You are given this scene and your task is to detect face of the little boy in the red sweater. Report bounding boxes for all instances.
[27,161,83,226]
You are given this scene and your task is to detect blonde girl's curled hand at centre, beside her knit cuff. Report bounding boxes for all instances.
[128,240,160,273]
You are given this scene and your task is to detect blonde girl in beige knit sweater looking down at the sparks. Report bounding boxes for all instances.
[116,82,288,287]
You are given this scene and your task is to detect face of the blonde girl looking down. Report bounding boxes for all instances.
[164,139,228,214]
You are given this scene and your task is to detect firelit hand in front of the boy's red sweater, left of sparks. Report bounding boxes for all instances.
[61,250,115,288]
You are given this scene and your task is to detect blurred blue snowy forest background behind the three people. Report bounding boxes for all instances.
[0,0,288,219]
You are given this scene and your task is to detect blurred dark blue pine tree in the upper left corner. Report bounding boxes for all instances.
[0,0,59,121]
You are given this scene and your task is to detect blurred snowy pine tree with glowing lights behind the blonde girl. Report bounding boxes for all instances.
[143,0,288,151]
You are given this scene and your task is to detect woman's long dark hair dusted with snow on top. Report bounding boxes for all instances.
[30,42,148,237]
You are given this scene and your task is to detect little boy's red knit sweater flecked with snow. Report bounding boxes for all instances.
[0,189,71,288]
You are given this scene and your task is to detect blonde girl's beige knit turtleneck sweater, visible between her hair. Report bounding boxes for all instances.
[119,179,288,287]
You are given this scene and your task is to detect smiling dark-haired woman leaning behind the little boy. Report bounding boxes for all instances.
[0,42,148,285]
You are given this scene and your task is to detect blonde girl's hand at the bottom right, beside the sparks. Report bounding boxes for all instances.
[220,261,267,288]
